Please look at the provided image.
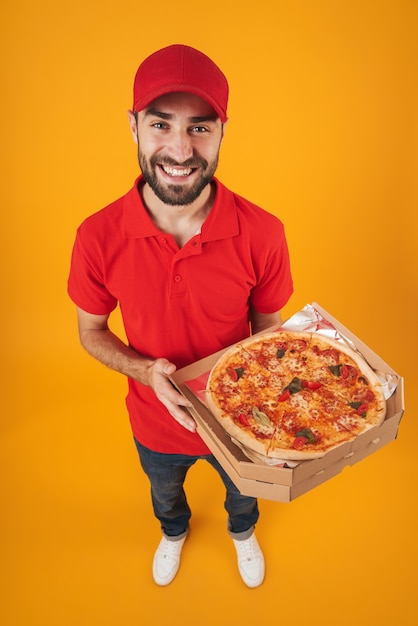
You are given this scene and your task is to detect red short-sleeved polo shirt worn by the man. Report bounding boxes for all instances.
[68,177,292,455]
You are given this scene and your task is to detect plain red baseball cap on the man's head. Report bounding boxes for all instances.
[133,44,228,123]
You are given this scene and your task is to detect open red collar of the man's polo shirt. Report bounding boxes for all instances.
[123,175,239,242]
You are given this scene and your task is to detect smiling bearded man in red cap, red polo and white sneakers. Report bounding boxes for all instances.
[68,45,292,587]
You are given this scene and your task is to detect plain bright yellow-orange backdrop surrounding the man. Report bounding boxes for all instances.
[0,0,418,626]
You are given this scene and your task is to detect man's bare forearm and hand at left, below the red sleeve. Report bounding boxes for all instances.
[77,308,196,432]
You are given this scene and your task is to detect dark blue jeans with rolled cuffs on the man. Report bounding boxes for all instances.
[135,440,259,539]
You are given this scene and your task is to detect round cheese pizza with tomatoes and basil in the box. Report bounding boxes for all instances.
[206,331,386,460]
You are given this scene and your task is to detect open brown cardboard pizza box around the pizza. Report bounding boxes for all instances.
[171,303,404,502]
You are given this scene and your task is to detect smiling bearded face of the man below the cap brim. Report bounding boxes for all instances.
[130,93,223,206]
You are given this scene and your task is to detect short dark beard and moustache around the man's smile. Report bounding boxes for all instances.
[138,142,218,206]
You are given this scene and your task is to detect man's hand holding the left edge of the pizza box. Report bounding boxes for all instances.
[148,359,196,433]
